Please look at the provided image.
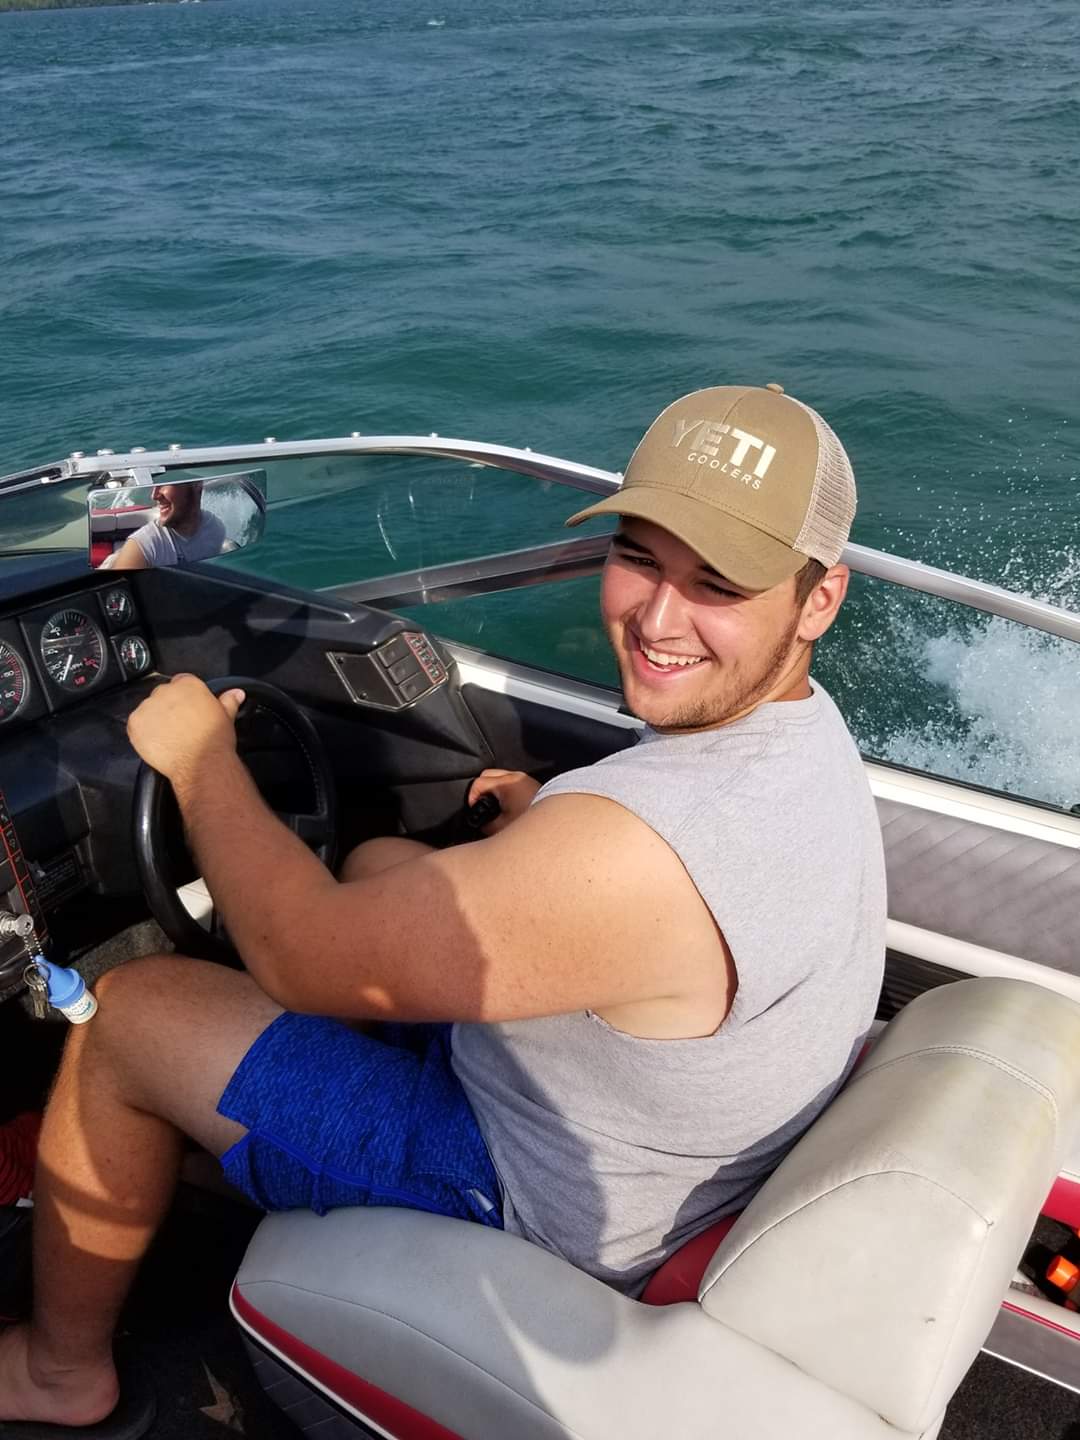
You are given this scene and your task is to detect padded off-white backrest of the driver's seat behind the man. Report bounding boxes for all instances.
[698,979,1080,1434]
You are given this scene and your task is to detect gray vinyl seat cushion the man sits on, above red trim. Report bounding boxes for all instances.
[238,1210,915,1440]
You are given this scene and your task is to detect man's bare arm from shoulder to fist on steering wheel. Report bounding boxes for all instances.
[131,677,730,1022]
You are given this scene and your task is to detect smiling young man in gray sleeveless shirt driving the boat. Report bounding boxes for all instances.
[0,386,884,1424]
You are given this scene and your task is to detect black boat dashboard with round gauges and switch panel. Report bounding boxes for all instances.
[0,560,504,998]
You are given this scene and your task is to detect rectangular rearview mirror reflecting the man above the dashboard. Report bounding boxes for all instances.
[86,469,266,570]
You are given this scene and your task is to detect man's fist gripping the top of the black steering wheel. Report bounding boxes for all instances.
[128,675,245,789]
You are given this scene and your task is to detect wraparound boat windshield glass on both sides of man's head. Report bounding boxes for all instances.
[0,442,1080,809]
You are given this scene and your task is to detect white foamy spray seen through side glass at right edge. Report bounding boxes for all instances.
[874,554,1080,808]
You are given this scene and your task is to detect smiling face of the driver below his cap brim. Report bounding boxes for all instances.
[600,518,805,732]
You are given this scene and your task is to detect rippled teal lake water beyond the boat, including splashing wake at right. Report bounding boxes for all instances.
[0,0,1080,804]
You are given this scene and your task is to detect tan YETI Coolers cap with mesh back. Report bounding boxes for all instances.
[566,384,855,590]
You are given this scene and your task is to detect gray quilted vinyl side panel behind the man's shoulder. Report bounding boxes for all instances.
[877,799,1080,975]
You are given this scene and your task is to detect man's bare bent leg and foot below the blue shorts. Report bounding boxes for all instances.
[0,956,281,1424]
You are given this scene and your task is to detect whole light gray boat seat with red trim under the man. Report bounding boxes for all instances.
[233,979,1080,1440]
